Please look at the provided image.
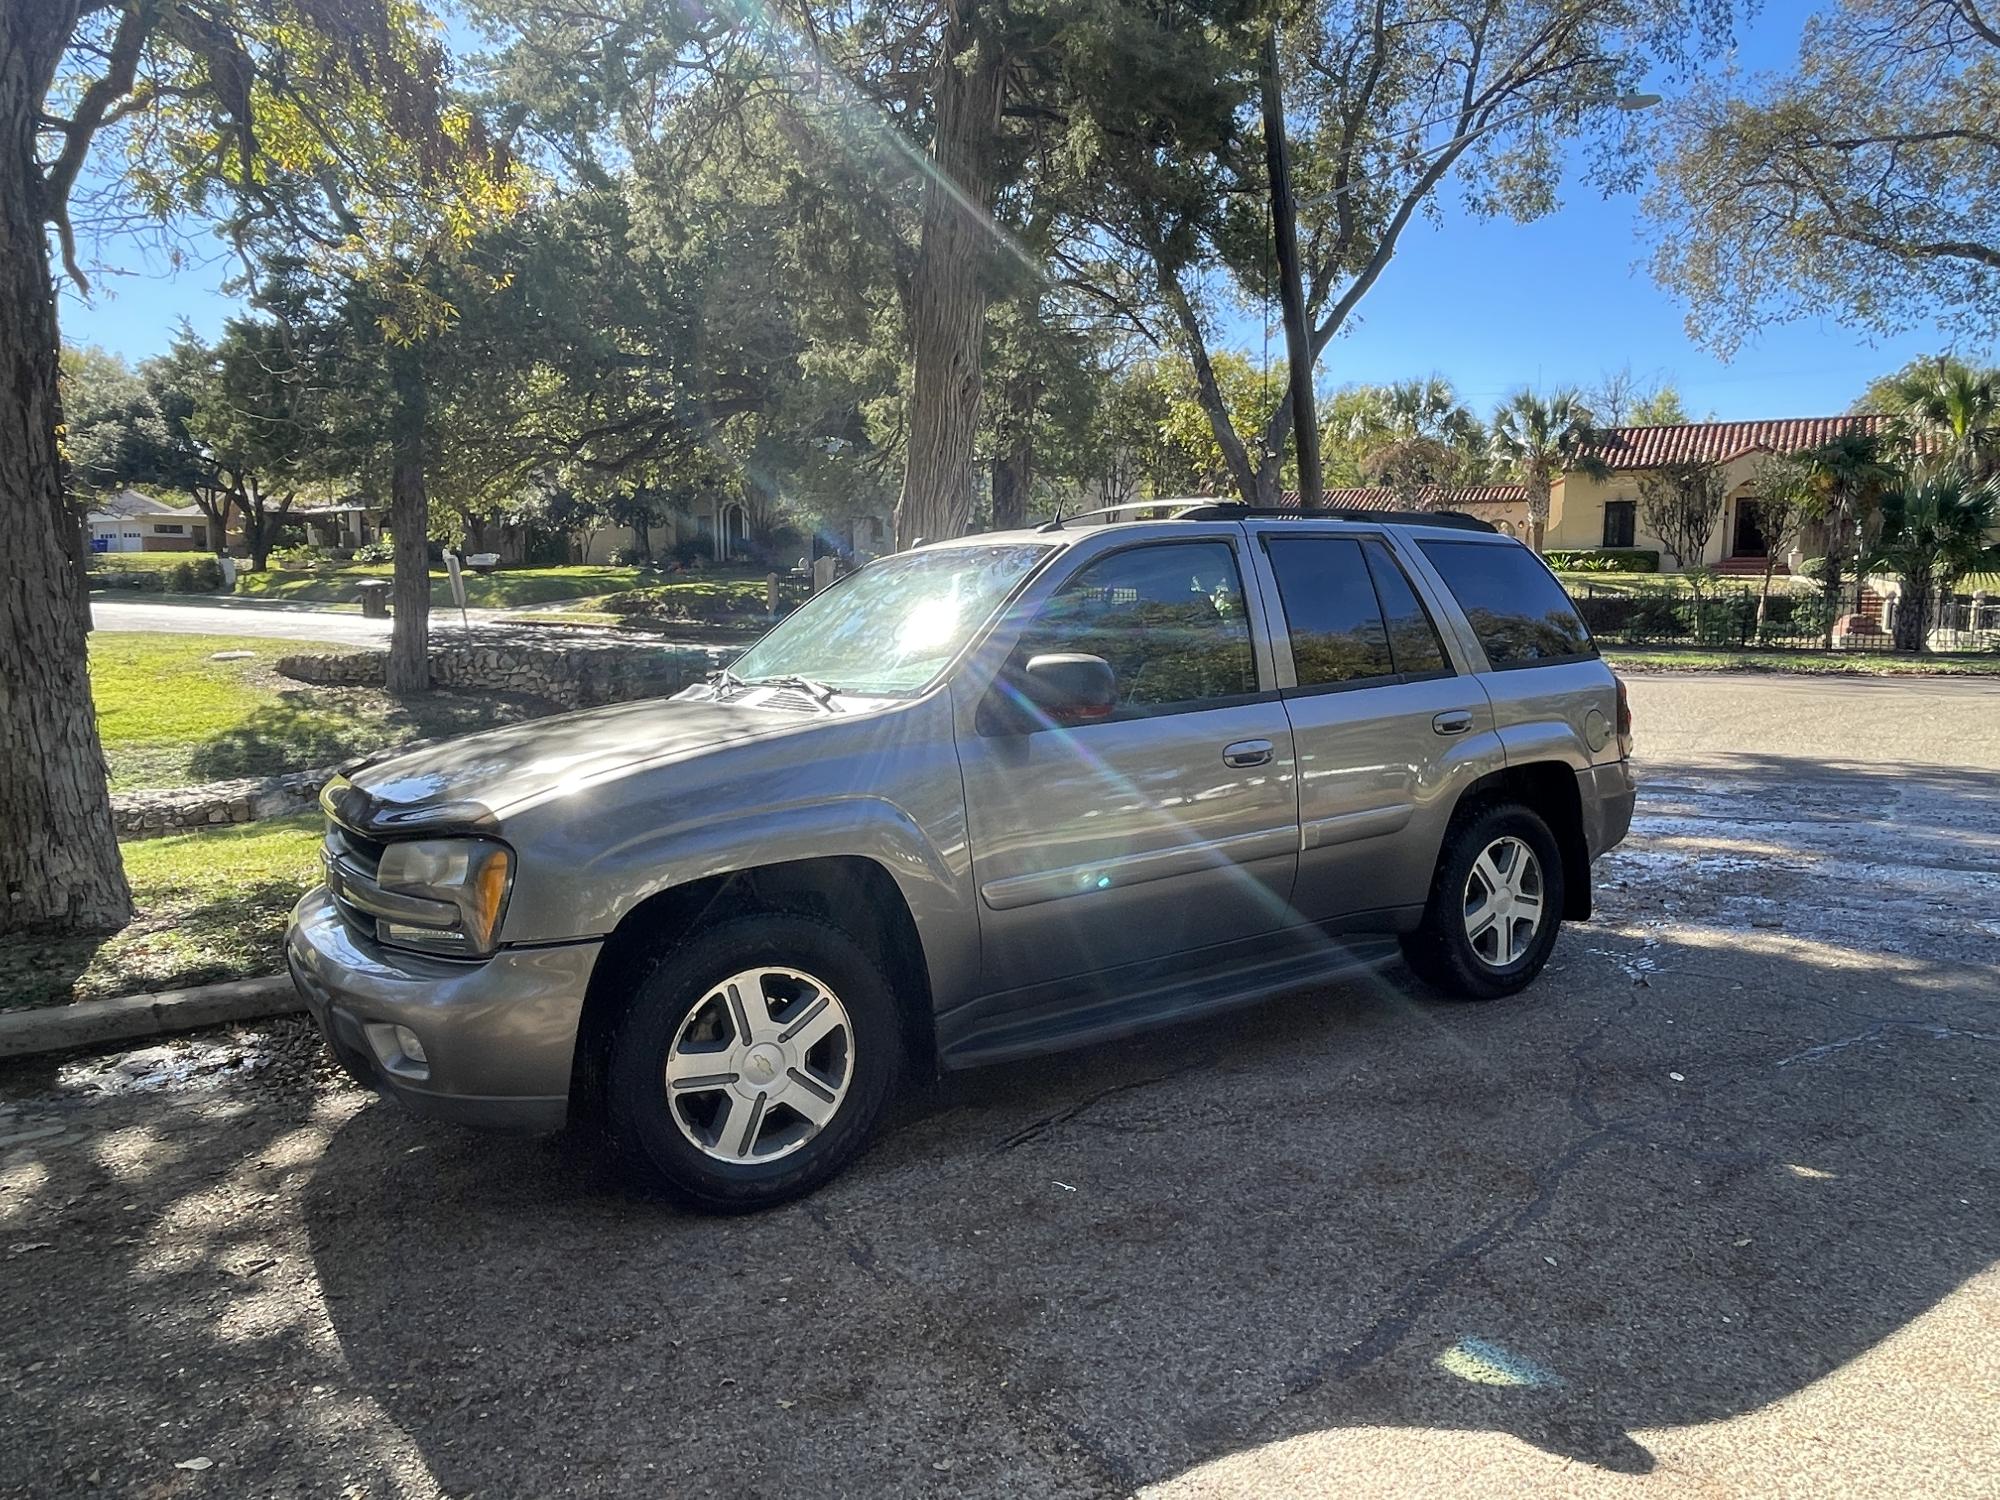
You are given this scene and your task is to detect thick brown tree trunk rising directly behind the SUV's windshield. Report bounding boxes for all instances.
[896,0,1006,548]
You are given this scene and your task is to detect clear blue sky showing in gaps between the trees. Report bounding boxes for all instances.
[62,0,1994,420]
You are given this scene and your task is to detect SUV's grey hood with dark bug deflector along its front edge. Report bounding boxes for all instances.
[322,698,812,834]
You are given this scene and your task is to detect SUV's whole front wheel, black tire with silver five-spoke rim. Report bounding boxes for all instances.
[606,914,902,1210]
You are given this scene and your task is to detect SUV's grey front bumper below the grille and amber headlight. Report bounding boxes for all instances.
[284,886,604,1132]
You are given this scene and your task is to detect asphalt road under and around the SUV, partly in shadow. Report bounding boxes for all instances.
[0,678,2000,1496]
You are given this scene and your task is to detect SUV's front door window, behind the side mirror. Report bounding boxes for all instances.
[1010,542,1258,710]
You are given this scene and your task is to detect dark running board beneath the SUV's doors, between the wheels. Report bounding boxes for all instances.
[938,934,1400,1068]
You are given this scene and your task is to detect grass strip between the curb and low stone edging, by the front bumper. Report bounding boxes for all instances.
[0,814,320,1010]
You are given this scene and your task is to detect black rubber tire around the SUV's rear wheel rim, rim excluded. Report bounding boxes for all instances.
[1402,802,1564,1000]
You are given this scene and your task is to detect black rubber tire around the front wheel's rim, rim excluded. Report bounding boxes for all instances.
[604,912,904,1214]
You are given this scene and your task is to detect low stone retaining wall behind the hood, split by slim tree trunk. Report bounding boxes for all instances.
[278,636,738,708]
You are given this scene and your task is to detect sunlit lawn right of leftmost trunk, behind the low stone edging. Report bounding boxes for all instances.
[90,632,550,792]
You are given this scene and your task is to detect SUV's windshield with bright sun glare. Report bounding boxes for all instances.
[730,542,1048,696]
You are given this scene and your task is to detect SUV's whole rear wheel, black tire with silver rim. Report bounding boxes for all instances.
[1402,802,1562,1000]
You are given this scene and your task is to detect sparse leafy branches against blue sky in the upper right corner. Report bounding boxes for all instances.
[1646,0,2000,350]
